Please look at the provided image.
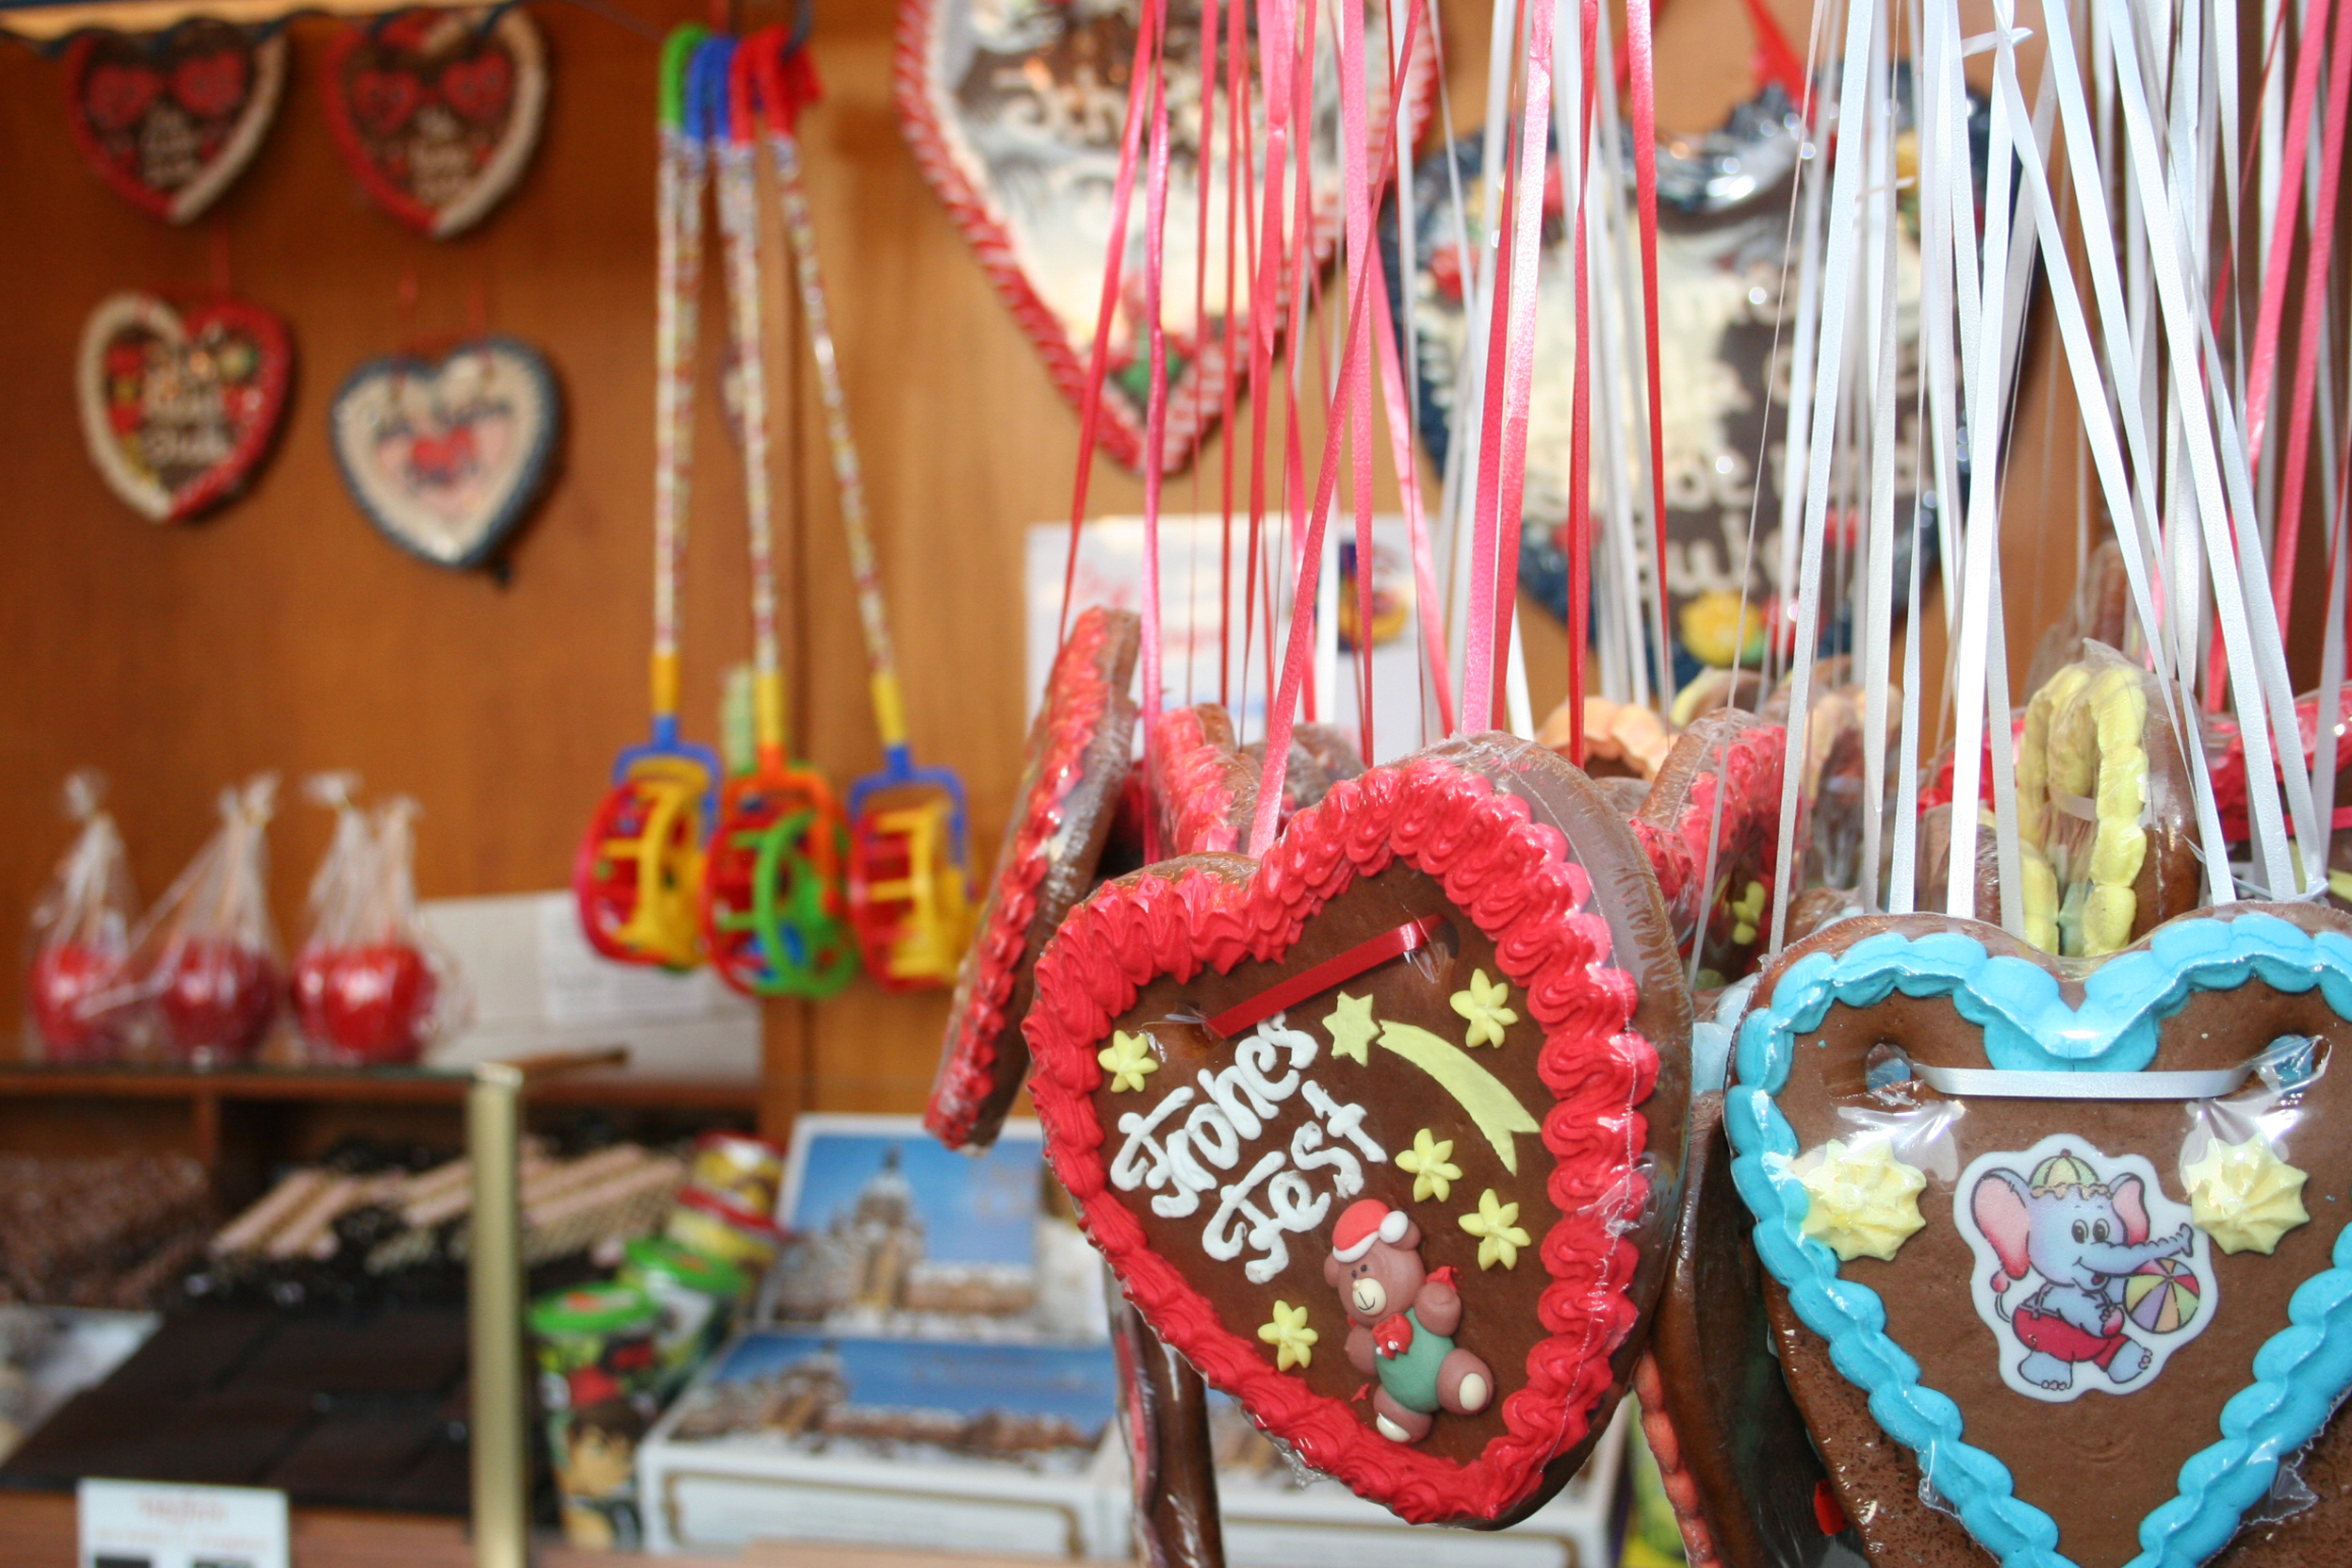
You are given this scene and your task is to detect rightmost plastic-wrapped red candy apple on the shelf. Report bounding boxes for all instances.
[294,780,468,1068]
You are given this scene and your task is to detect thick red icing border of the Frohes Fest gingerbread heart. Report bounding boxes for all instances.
[1025,757,1658,1524]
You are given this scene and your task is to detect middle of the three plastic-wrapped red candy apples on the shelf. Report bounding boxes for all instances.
[134,774,285,1068]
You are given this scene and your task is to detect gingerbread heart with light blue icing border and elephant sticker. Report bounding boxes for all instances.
[1740,903,2352,1568]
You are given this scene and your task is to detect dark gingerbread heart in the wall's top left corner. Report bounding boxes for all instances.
[66,19,287,223]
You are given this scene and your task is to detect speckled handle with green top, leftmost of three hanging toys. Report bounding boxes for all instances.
[651,24,710,745]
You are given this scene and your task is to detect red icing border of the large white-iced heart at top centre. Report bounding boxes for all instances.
[891,0,1437,472]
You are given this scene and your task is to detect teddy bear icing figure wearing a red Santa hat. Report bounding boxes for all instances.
[1324,1199,1494,1444]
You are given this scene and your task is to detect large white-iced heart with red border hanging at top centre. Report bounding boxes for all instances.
[896,0,1437,472]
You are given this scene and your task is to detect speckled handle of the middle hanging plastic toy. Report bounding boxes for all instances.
[696,40,783,766]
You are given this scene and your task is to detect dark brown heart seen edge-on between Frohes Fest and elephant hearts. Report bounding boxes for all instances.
[1644,1093,1860,1568]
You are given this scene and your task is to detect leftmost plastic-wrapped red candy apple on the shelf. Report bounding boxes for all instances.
[25,769,139,1063]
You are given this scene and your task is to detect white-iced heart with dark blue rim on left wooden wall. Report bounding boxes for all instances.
[327,336,563,566]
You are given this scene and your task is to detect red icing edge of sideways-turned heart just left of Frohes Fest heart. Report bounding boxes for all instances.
[922,609,1127,1150]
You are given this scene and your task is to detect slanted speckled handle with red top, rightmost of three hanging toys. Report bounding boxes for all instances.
[743,28,912,774]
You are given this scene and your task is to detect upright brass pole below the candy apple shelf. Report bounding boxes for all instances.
[466,1063,531,1568]
